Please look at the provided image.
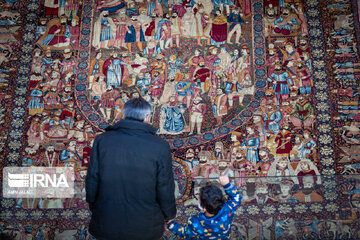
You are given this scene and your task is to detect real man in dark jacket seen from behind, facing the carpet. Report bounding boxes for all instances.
[86,98,176,240]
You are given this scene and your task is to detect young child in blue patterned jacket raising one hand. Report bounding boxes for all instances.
[168,176,241,239]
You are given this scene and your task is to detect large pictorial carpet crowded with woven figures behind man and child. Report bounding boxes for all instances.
[0,0,360,240]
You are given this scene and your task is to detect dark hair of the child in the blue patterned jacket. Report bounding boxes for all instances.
[200,184,225,215]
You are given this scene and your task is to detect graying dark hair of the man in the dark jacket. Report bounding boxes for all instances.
[124,97,152,121]
